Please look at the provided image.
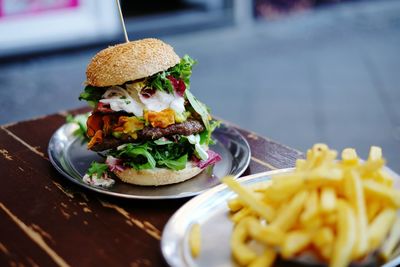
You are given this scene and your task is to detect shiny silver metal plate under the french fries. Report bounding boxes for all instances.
[161,168,400,267]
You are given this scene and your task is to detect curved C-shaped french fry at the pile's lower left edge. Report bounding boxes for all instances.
[231,218,257,266]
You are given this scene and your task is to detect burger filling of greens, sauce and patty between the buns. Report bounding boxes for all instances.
[79,56,220,177]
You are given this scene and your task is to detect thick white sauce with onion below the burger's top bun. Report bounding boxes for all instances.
[100,86,185,117]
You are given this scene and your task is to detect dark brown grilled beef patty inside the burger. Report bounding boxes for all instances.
[91,120,204,151]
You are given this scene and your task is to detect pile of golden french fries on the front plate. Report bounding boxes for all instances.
[223,144,400,267]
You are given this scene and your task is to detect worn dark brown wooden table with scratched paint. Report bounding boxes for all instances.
[0,110,302,266]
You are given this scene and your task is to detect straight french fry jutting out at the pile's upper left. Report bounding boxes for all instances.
[222,176,275,222]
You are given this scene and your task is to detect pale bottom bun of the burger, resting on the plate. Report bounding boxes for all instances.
[115,163,202,186]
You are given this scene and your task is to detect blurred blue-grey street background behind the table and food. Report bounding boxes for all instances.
[0,0,400,171]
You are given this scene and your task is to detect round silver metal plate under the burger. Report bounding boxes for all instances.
[48,124,250,199]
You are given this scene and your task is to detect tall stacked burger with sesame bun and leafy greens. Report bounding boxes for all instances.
[79,39,221,186]
